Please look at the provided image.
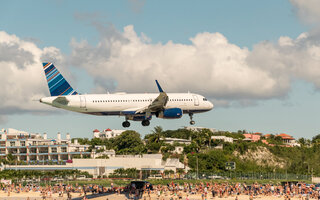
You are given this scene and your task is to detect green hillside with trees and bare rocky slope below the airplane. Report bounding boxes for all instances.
[74,127,320,176]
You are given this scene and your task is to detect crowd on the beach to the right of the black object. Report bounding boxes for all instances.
[130,182,320,200]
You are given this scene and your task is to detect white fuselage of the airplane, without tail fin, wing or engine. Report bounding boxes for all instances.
[40,93,213,116]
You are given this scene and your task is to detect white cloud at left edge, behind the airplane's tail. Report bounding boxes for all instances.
[0,31,62,116]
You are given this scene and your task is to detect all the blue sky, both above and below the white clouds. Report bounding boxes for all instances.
[0,0,320,138]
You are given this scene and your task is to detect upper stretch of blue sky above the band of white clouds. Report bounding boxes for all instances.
[0,0,308,49]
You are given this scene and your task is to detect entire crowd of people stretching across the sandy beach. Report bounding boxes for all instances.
[1,182,320,200]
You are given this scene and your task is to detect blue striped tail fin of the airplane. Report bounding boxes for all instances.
[42,63,78,96]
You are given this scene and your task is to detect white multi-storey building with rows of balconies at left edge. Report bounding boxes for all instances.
[0,129,91,164]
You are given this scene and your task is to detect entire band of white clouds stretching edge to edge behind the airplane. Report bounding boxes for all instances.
[0,5,320,117]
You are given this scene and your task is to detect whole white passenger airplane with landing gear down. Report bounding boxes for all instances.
[39,62,213,128]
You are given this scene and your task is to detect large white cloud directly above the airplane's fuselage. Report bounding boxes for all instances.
[71,25,289,103]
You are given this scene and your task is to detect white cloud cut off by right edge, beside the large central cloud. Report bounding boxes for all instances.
[248,33,320,89]
